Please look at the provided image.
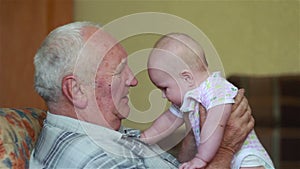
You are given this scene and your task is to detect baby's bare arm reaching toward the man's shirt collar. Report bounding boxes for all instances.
[141,110,183,144]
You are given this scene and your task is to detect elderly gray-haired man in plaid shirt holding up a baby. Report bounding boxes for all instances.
[30,22,254,169]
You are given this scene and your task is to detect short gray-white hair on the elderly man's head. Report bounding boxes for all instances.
[34,22,100,102]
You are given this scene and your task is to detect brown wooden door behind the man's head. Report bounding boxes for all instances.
[0,0,73,108]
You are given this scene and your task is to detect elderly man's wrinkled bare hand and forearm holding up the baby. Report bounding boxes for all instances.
[178,89,254,169]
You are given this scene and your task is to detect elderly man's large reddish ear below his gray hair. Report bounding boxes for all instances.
[62,75,88,109]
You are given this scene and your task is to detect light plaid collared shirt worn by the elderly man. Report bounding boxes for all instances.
[29,112,179,169]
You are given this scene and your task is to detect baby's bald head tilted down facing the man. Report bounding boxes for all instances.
[148,33,208,106]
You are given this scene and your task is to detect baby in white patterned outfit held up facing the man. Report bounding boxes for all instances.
[141,33,274,169]
